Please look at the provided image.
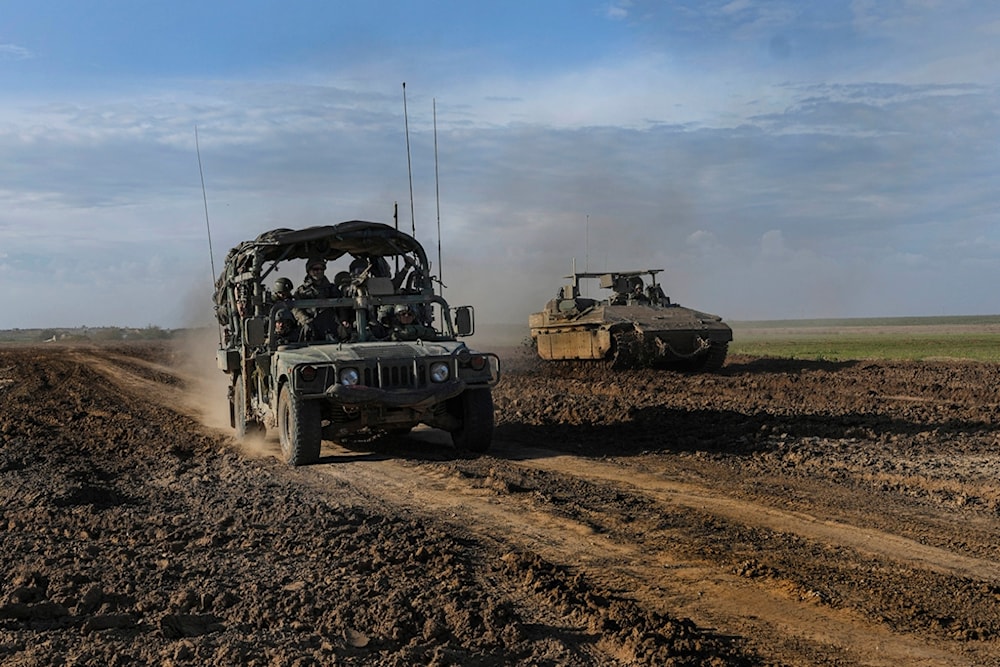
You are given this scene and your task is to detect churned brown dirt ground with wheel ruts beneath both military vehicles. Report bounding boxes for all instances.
[0,344,1000,667]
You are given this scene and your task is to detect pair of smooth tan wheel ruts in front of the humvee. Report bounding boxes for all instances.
[304,435,1000,667]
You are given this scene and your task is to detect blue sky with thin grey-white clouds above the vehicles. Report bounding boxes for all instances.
[0,0,1000,329]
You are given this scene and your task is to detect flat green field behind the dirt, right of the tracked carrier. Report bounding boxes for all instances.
[729,315,1000,362]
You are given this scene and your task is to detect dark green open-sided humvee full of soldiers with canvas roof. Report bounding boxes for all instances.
[214,220,500,465]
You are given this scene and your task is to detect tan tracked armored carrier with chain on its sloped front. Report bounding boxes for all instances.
[528,269,733,371]
